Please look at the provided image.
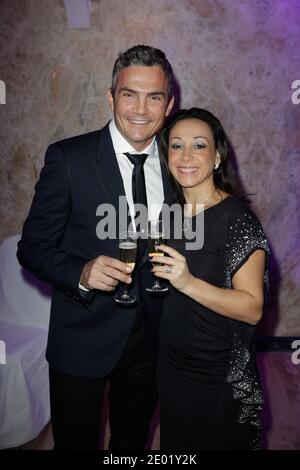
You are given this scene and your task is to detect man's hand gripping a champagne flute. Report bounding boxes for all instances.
[80,255,132,292]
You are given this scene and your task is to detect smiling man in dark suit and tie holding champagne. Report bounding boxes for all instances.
[18,46,174,450]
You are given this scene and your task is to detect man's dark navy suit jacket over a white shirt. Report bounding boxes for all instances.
[17,125,173,377]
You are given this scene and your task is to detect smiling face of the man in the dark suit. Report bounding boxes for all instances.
[108,65,174,152]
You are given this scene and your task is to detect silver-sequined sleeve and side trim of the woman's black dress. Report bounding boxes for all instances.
[223,200,270,449]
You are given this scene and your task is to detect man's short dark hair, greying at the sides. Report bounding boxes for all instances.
[111,45,173,99]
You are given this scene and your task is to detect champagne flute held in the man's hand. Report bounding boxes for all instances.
[114,232,137,305]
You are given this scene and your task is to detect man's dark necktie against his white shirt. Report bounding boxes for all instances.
[124,153,148,255]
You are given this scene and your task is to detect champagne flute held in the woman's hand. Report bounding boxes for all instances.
[146,220,168,292]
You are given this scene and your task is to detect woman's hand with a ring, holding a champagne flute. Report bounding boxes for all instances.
[150,245,193,293]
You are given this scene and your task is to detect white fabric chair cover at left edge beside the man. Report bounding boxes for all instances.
[0,235,51,449]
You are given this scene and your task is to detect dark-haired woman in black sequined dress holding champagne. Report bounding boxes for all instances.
[152,108,269,449]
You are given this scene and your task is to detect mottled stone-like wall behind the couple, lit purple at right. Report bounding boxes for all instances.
[0,0,300,335]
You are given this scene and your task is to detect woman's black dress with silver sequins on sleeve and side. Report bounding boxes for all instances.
[158,196,269,449]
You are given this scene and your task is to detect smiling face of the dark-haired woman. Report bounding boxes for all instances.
[168,118,221,188]
